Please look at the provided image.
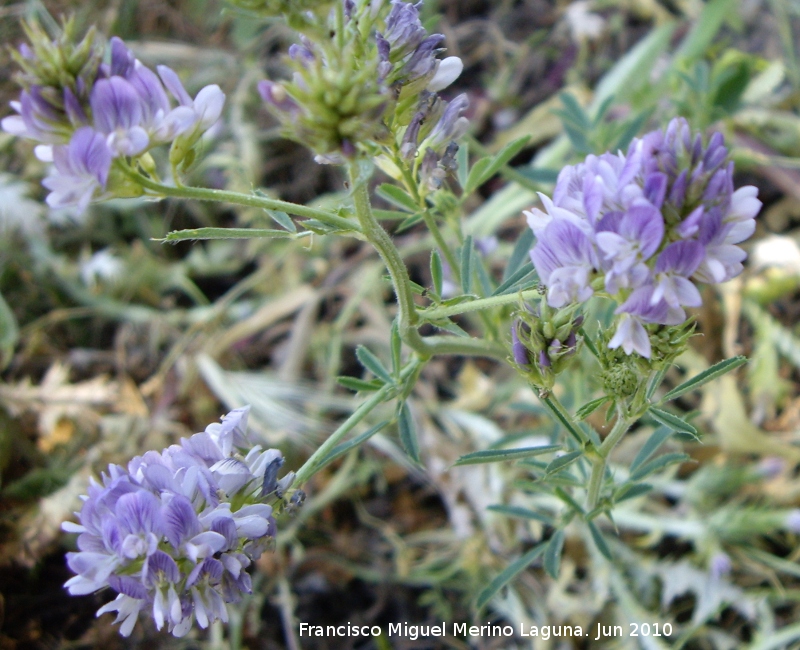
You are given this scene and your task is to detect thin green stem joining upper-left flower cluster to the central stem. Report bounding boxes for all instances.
[120,165,359,232]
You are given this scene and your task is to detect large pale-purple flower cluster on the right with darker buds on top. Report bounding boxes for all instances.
[526,118,761,358]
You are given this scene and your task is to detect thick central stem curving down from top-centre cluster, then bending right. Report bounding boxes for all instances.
[350,163,507,359]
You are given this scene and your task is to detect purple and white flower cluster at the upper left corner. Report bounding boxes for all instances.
[2,32,225,211]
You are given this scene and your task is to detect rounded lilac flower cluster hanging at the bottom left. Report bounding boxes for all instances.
[63,407,293,636]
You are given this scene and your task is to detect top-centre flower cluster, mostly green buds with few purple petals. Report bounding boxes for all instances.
[259,0,469,171]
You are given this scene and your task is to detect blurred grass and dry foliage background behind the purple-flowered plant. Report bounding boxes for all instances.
[0,0,800,650]
